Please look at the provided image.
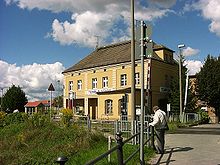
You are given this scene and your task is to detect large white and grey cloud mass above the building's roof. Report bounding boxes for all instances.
[6,0,176,47]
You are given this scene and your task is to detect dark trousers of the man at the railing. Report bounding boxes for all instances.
[155,129,165,153]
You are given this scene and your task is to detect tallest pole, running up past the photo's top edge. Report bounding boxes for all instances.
[131,0,136,138]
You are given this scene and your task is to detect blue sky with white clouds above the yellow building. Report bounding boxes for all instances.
[0,0,220,100]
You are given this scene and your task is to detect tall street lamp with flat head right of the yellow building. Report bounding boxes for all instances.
[178,44,185,122]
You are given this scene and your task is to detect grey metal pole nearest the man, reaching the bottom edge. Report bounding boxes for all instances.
[140,21,144,165]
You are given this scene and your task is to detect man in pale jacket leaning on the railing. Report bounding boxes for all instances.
[149,106,168,154]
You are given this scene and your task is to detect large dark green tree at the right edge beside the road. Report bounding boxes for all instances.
[196,55,220,120]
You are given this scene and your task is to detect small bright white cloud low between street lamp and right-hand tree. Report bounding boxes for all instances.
[184,60,203,75]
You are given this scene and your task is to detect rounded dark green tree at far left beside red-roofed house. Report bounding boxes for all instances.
[2,85,27,113]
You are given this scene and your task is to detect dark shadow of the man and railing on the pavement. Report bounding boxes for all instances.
[154,147,193,165]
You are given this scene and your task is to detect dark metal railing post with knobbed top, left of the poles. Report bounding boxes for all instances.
[115,132,123,165]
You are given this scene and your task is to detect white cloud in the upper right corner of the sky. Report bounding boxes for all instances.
[185,0,220,36]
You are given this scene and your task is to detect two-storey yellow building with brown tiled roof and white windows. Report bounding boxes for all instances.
[63,41,178,120]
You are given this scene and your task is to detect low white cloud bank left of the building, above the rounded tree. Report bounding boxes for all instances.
[0,60,64,100]
